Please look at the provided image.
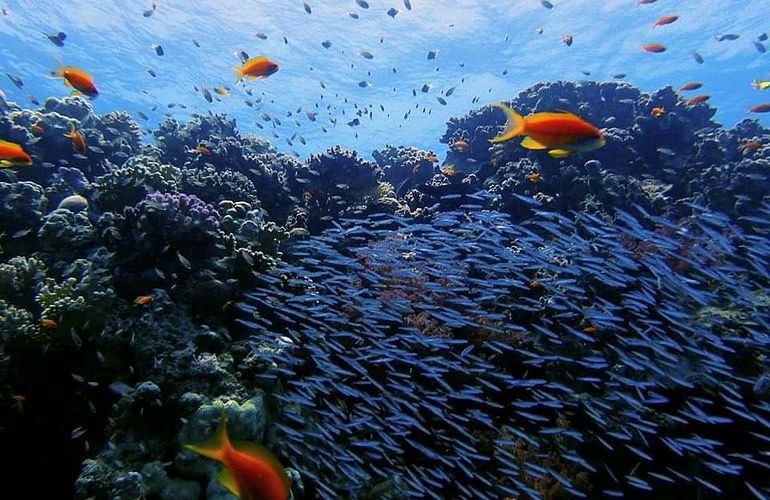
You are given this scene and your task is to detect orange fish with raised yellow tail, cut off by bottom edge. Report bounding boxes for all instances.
[185,411,291,500]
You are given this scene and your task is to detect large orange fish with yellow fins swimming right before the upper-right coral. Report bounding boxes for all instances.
[489,103,605,158]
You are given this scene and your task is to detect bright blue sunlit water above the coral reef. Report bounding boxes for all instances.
[0,0,770,156]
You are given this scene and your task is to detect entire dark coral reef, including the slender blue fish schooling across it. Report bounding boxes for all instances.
[0,82,770,499]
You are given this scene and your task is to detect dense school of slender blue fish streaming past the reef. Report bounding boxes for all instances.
[240,202,770,499]
